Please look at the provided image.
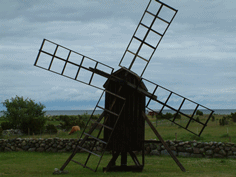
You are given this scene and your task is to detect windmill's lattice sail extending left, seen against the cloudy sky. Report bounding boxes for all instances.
[34,39,114,90]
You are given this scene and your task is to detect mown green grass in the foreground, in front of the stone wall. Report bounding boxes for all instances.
[0,152,236,177]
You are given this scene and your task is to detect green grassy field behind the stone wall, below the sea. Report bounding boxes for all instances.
[0,115,236,143]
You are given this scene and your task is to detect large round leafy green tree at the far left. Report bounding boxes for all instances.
[2,96,46,134]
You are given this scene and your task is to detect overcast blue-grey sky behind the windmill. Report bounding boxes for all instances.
[0,0,236,110]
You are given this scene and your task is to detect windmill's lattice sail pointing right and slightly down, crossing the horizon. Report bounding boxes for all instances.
[142,78,214,136]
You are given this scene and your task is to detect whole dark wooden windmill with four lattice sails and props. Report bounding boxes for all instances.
[34,0,214,172]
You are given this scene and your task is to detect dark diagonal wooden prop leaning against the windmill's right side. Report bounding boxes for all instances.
[143,112,186,172]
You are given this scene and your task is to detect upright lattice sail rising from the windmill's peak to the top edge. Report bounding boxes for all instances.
[119,0,178,77]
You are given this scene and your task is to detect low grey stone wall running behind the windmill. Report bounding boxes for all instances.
[0,138,236,158]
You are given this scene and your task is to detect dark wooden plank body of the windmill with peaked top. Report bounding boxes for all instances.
[104,68,147,171]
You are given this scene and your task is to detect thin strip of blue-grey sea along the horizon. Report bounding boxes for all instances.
[0,109,236,116]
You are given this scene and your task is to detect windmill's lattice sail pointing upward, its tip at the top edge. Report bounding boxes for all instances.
[119,0,177,76]
